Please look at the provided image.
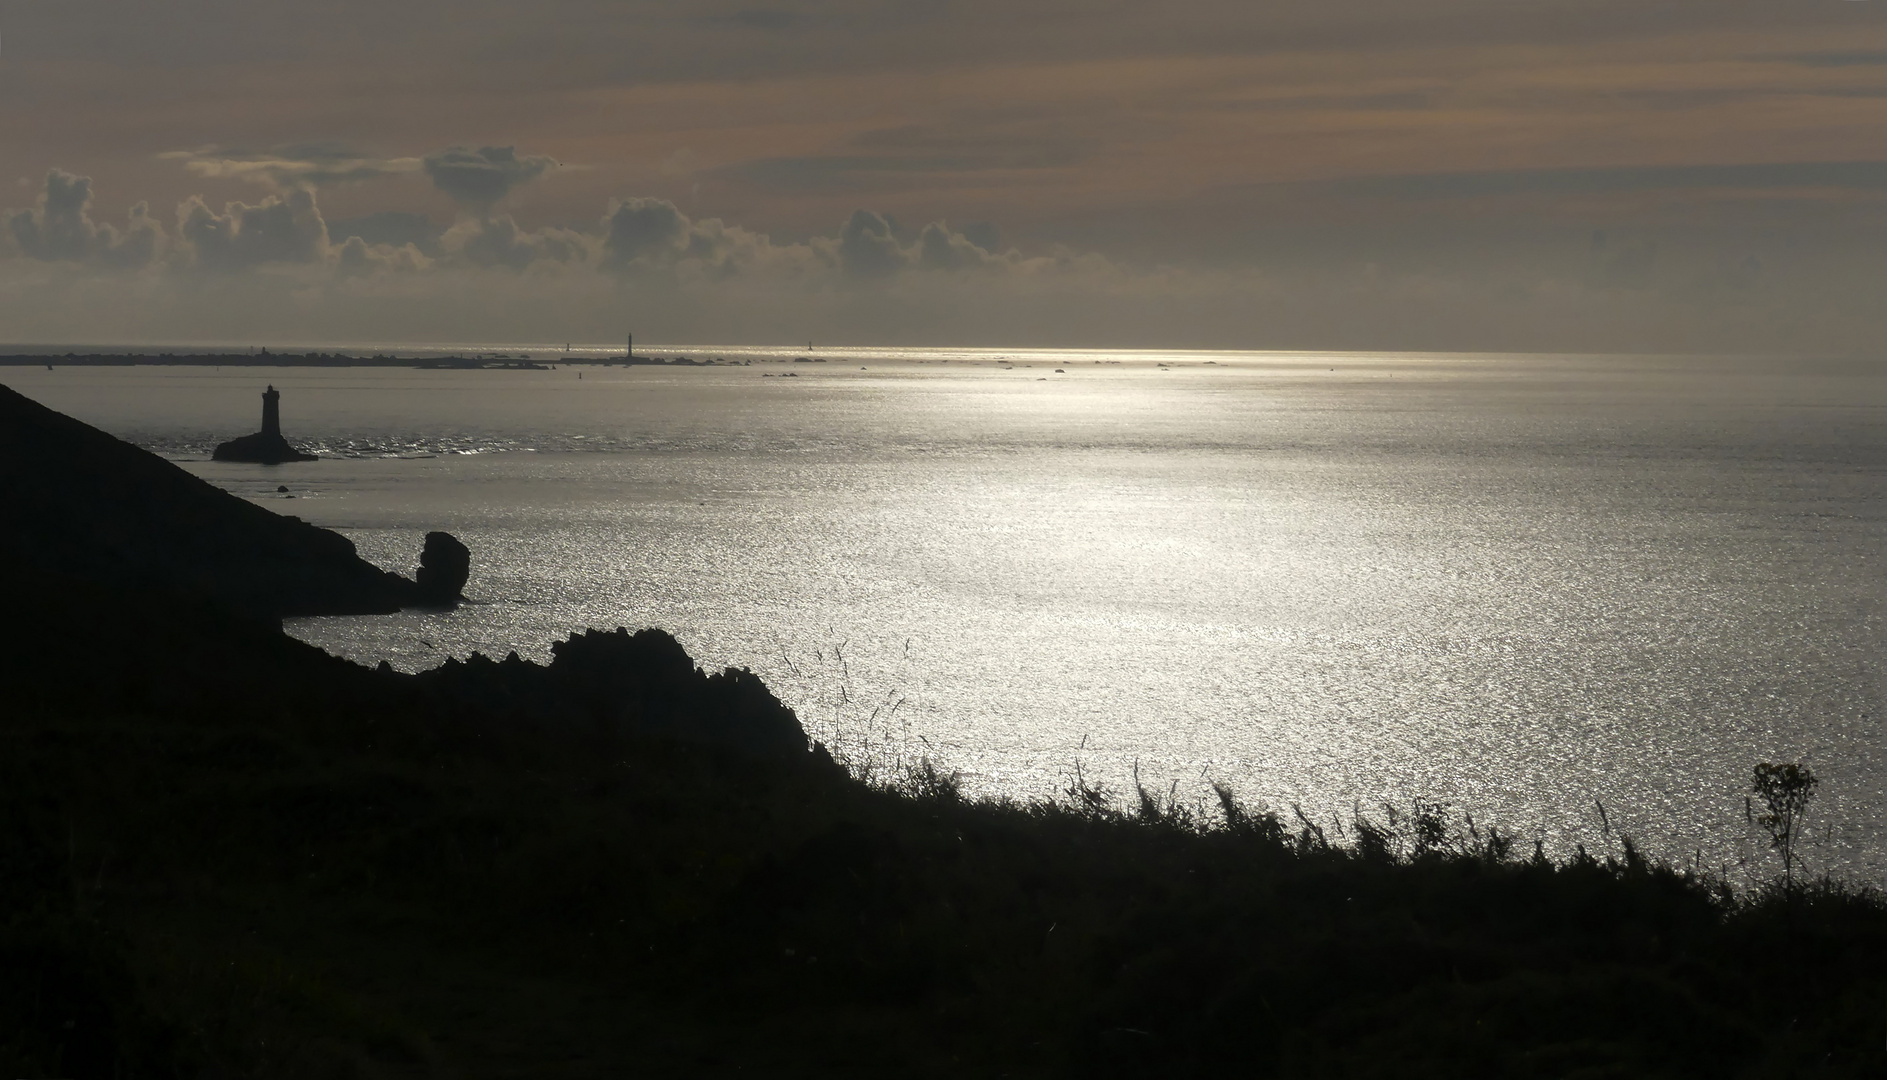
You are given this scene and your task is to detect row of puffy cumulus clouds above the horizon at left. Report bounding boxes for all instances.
[4,147,1032,281]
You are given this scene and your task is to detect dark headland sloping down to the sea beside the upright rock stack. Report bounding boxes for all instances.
[0,387,432,619]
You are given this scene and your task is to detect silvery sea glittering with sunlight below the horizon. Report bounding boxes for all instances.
[0,344,1887,886]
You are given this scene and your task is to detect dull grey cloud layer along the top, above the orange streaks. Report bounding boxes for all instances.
[8,0,1872,81]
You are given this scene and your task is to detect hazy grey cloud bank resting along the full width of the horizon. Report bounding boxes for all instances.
[0,183,1887,351]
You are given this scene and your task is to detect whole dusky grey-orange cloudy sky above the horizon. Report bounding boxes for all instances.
[0,0,1887,355]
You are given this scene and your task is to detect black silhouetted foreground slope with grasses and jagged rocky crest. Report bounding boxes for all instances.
[0,383,1887,1078]
